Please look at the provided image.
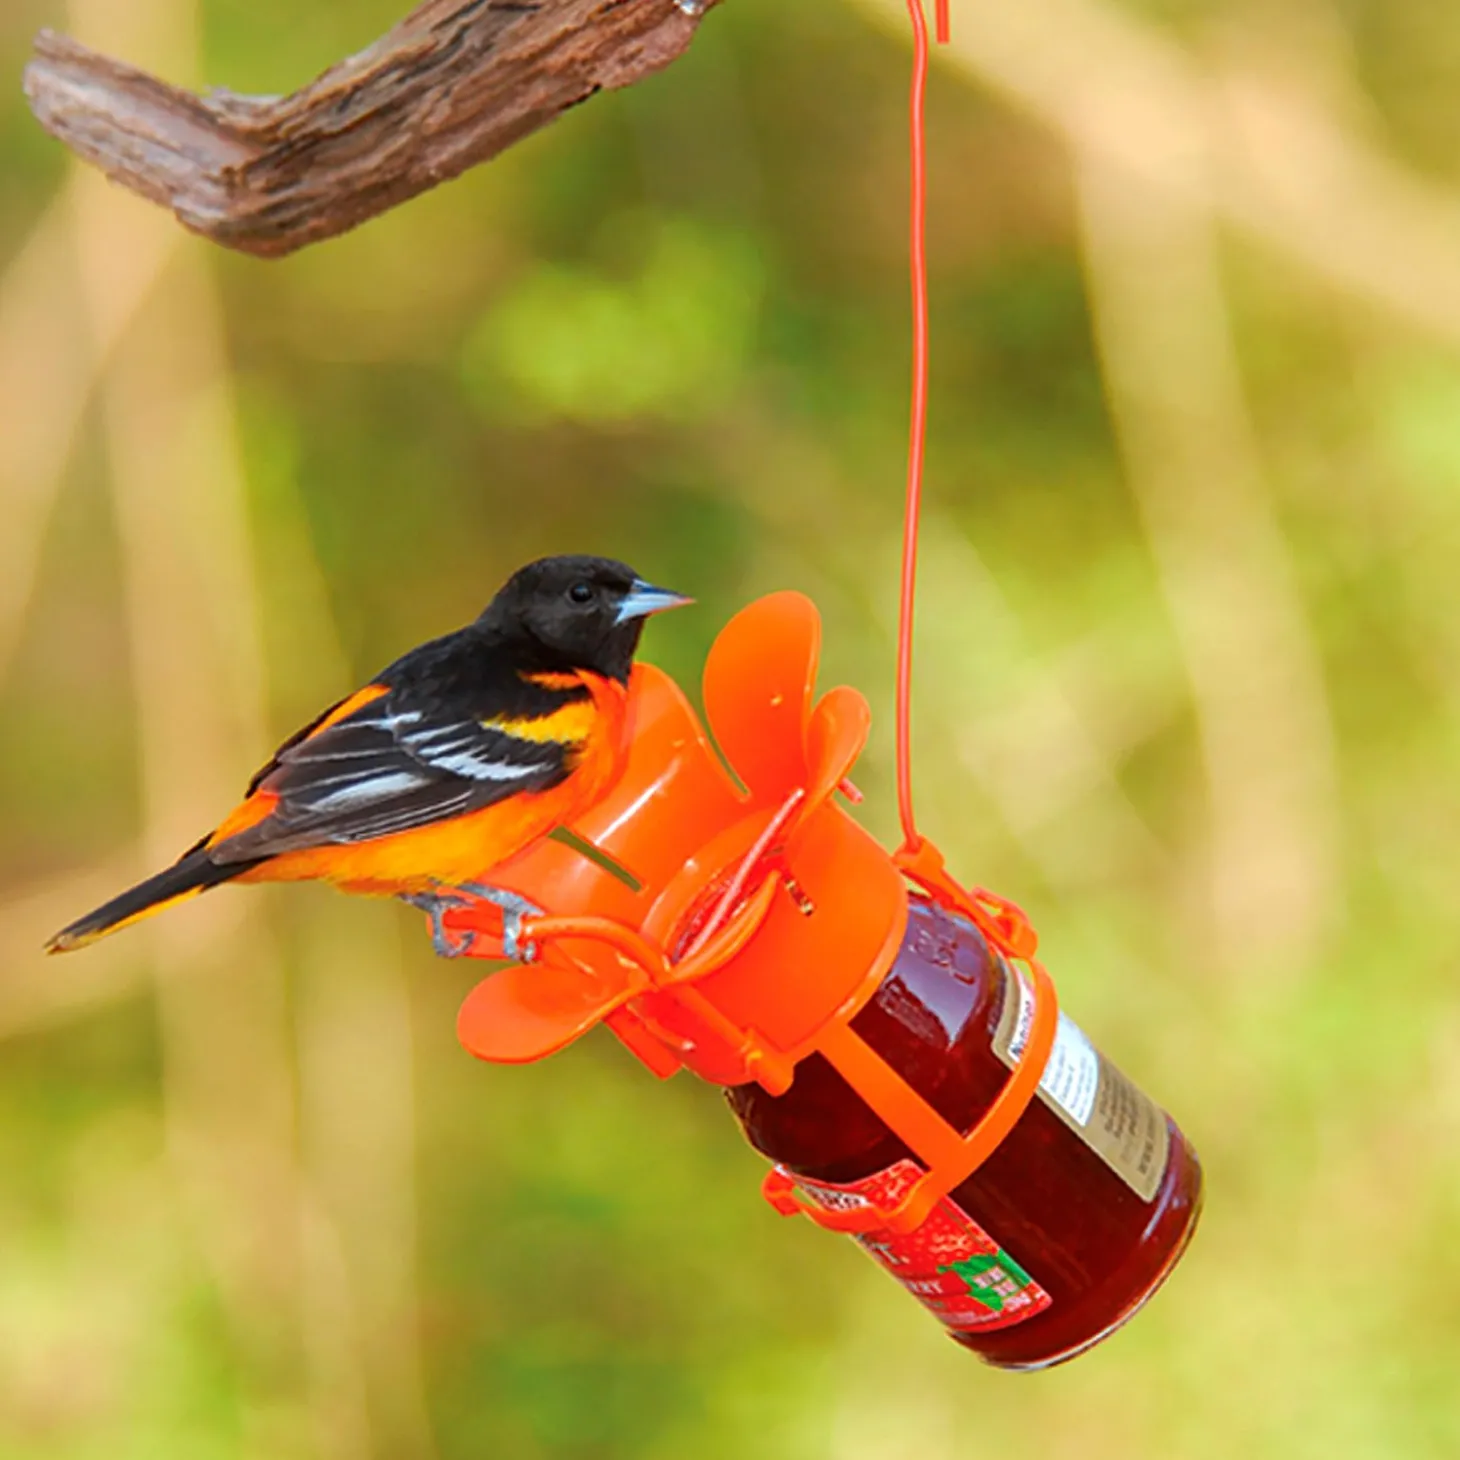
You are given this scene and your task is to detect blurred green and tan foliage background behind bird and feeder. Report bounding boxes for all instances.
[0,0,1460,1460]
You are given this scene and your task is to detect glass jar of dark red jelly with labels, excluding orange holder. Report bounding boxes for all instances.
[727,896,1202,1369]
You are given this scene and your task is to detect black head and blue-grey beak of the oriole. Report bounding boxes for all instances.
[477,556,694,680]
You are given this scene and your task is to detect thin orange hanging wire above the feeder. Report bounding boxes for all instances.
[896,0,949,851]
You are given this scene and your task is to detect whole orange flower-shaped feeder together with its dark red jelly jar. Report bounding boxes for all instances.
[445,593,1200,1368]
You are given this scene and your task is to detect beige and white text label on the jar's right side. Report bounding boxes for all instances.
[994,959,1171,1202]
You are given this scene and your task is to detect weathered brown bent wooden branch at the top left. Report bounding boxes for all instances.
[25,0,717,257]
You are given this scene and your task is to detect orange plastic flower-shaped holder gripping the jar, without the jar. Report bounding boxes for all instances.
[445,593,1059,1232]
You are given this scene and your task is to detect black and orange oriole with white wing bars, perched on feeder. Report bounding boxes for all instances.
[47,555,694,956]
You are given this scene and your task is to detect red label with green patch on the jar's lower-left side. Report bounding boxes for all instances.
[783,1159,1050,1333]
